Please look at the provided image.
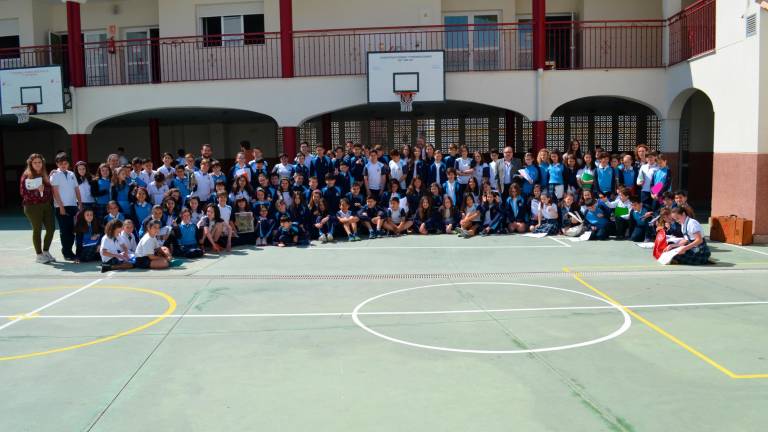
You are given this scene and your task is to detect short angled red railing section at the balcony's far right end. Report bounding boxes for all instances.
[669,0,716,66]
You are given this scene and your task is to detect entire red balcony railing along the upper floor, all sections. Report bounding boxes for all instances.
[0,0,715,87]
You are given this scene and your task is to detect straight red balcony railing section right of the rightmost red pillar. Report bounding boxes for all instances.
[546,20,664,69]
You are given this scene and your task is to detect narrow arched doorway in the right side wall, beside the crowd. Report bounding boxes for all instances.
[673,90,715,209]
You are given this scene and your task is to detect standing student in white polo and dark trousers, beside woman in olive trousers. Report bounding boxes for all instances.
[46,153,82,261]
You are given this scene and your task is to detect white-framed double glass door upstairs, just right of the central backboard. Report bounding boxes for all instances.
[443,12,500,71]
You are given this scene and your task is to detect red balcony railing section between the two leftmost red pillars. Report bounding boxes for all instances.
[84,33,280,86]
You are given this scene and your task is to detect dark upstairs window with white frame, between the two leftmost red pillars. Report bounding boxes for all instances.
[200,14,264,47]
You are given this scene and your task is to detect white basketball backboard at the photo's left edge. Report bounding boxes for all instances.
[0,66,64,114]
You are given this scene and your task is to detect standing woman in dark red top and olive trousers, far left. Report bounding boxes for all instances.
[19,153,56,264]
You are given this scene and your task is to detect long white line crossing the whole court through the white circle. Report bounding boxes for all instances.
[0,298,768,319]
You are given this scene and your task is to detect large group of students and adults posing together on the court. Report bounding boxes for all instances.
[20,139,709,271]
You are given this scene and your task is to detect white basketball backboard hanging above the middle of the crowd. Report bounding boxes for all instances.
[368,51,445,103]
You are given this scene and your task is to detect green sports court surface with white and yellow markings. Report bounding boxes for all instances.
[0,217,768,431]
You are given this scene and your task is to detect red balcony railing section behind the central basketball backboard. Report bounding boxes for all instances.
[293,23,531,76]
